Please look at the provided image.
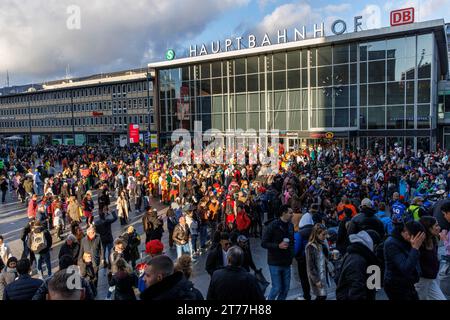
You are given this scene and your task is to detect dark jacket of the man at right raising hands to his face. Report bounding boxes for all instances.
[384,230,420,294]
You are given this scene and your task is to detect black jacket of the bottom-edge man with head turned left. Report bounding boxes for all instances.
[141,272,204,300]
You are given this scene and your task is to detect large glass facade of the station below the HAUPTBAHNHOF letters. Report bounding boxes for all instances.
[157,33,435,151]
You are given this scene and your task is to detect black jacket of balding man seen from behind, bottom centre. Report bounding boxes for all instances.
[206,266,265,301]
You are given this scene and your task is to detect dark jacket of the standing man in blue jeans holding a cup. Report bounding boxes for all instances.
[261,219,294,267]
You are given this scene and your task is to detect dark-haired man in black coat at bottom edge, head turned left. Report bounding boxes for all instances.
[141,255,203,300]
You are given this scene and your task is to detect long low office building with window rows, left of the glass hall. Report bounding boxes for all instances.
[0,69,156,145]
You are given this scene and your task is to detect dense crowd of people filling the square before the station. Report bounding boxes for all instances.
[0,142,450,301]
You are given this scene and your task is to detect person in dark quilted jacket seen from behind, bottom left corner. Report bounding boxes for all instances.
[3,259,43,300]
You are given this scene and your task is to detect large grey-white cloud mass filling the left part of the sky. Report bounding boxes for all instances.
[0,0,250,81]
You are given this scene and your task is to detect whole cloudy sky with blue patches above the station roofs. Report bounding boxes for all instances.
[0,0,450,87]
